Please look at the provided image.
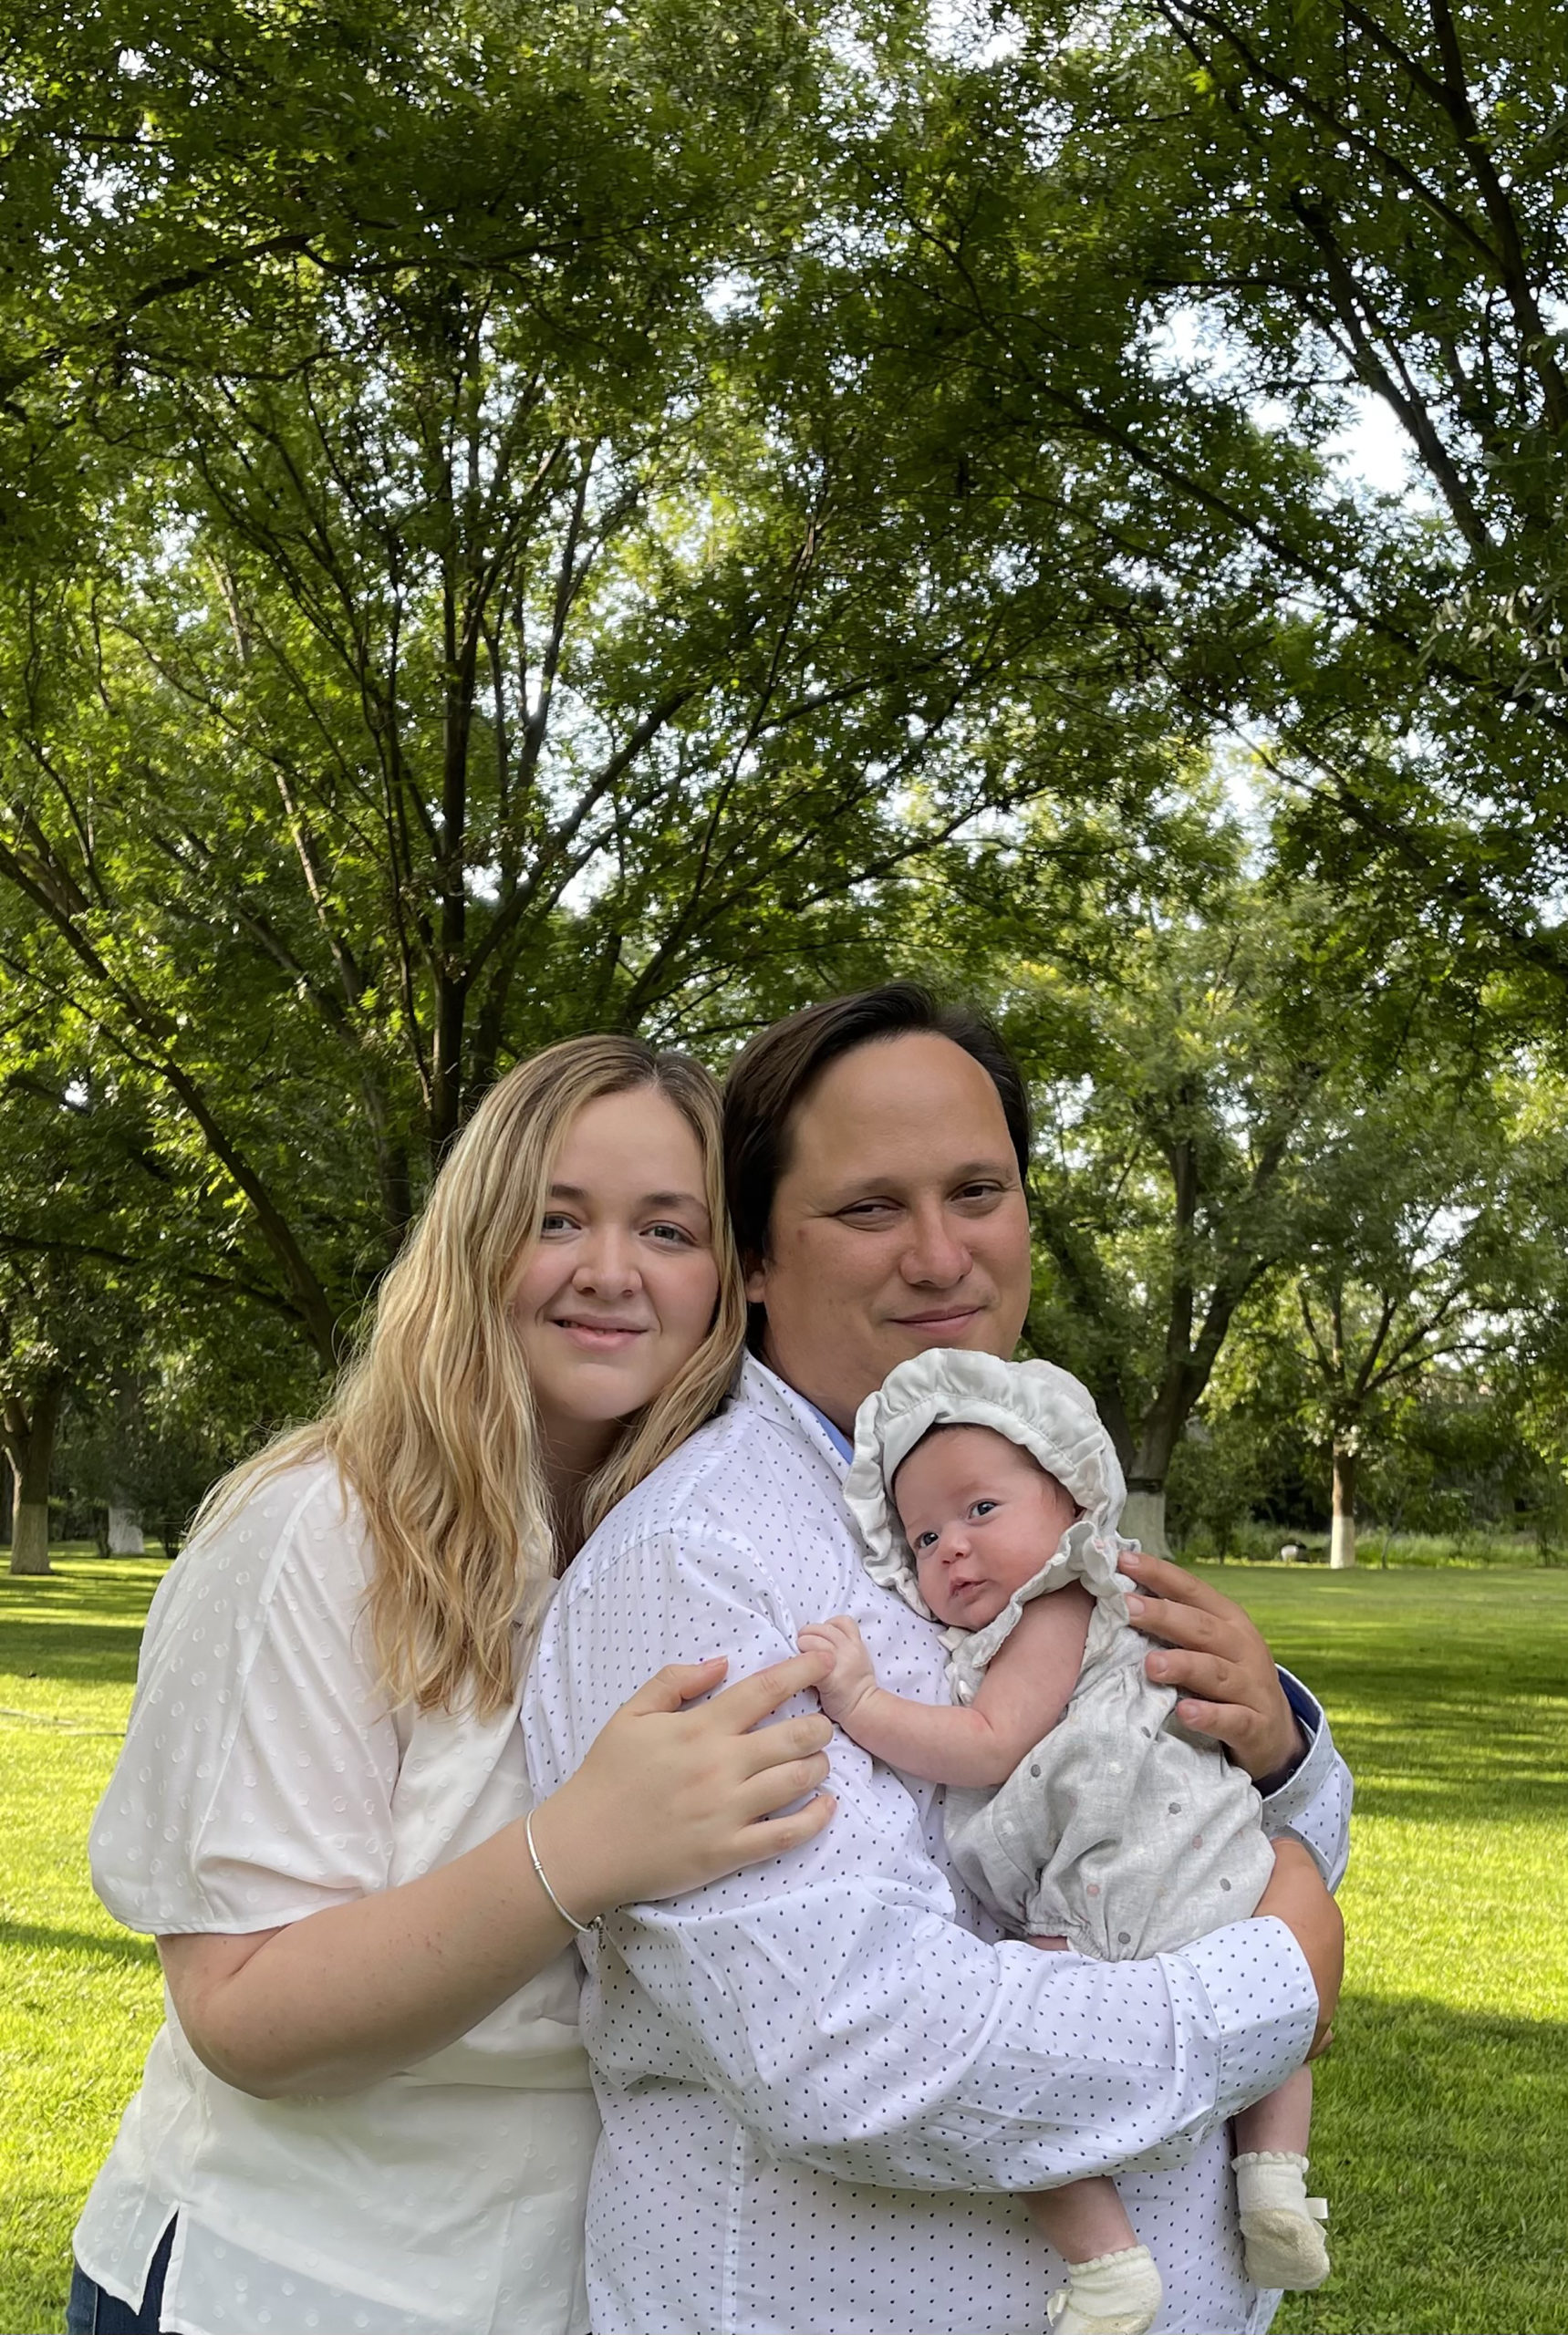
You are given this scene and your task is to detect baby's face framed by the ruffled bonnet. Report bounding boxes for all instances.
[893,1427,1077,1630]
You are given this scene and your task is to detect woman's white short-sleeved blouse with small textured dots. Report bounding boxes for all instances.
[75,1462,598,2335]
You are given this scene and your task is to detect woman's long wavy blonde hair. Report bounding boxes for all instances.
[199,1037,745,1717]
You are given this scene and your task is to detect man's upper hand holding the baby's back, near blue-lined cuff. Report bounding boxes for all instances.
[1117,1552,1306,1784]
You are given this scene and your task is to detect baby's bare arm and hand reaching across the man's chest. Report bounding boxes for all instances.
[799,1581,1094,1784]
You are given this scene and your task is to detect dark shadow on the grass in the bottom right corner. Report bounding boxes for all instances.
[1276,1997,1568,2335]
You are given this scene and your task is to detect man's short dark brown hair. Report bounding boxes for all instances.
[724,981,1028,1268]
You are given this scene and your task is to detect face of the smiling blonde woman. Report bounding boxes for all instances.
[512,1085,720,1464]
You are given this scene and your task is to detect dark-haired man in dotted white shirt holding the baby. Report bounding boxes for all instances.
[524,983,1348,2335]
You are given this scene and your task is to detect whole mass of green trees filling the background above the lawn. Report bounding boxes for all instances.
[0,0,1568,1569]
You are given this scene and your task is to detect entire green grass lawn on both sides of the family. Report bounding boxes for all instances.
[0,1555,1568,2335]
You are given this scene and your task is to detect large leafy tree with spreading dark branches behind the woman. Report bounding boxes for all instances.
[0,0,1205,1359]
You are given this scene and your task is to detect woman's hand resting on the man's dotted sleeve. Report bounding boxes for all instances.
[533,1653,836,1922]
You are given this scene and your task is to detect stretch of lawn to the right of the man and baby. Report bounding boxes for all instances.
[1206,1564,1568,2335]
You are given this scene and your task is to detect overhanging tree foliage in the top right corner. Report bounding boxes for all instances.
[832,0,1568,1021]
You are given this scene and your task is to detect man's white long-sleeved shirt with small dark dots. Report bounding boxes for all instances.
[524,1359,1348,2335]
